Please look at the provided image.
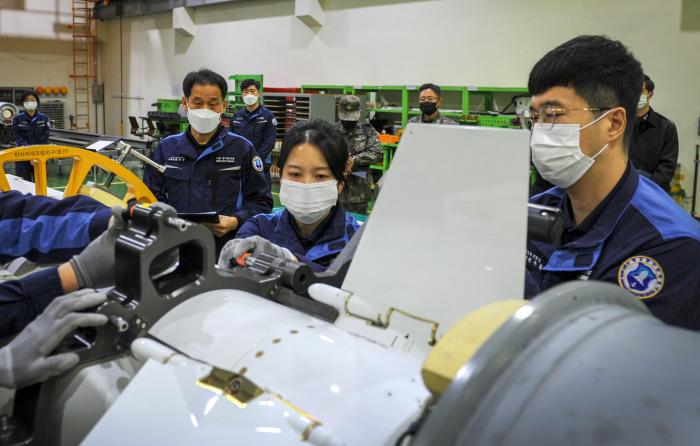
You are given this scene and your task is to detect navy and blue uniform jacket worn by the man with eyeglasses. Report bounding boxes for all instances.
[525,163,700,329]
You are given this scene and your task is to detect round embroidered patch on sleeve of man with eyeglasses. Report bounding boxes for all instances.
[617,256,664,299]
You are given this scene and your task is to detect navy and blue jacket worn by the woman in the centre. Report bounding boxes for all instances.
[236,203,360,271]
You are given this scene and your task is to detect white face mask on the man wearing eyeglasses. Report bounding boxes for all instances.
[530,110,612,189]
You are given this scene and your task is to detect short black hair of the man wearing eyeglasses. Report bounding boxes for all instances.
[527,36,644,147]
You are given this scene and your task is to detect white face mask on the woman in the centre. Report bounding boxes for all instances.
[280,179,338,225]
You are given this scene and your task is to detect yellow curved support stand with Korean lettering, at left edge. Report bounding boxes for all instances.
[0,145,158,206]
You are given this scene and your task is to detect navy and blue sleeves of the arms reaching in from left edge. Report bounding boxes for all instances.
[0,191,112,338]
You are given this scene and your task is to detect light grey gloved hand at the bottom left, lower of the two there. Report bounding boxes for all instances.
[0,290,107,389]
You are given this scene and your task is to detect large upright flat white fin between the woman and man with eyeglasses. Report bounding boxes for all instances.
[343,124,529,342]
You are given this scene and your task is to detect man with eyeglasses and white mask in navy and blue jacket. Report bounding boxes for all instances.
[523,36,700,329]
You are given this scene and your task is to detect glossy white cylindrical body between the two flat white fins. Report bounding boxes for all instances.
[148,290,429,445]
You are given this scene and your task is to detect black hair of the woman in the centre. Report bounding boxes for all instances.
[277,119,350,183]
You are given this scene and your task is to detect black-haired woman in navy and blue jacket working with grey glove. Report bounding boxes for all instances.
[219,120,360,271]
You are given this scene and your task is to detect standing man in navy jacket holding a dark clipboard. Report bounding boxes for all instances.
[143,69,272,251]
